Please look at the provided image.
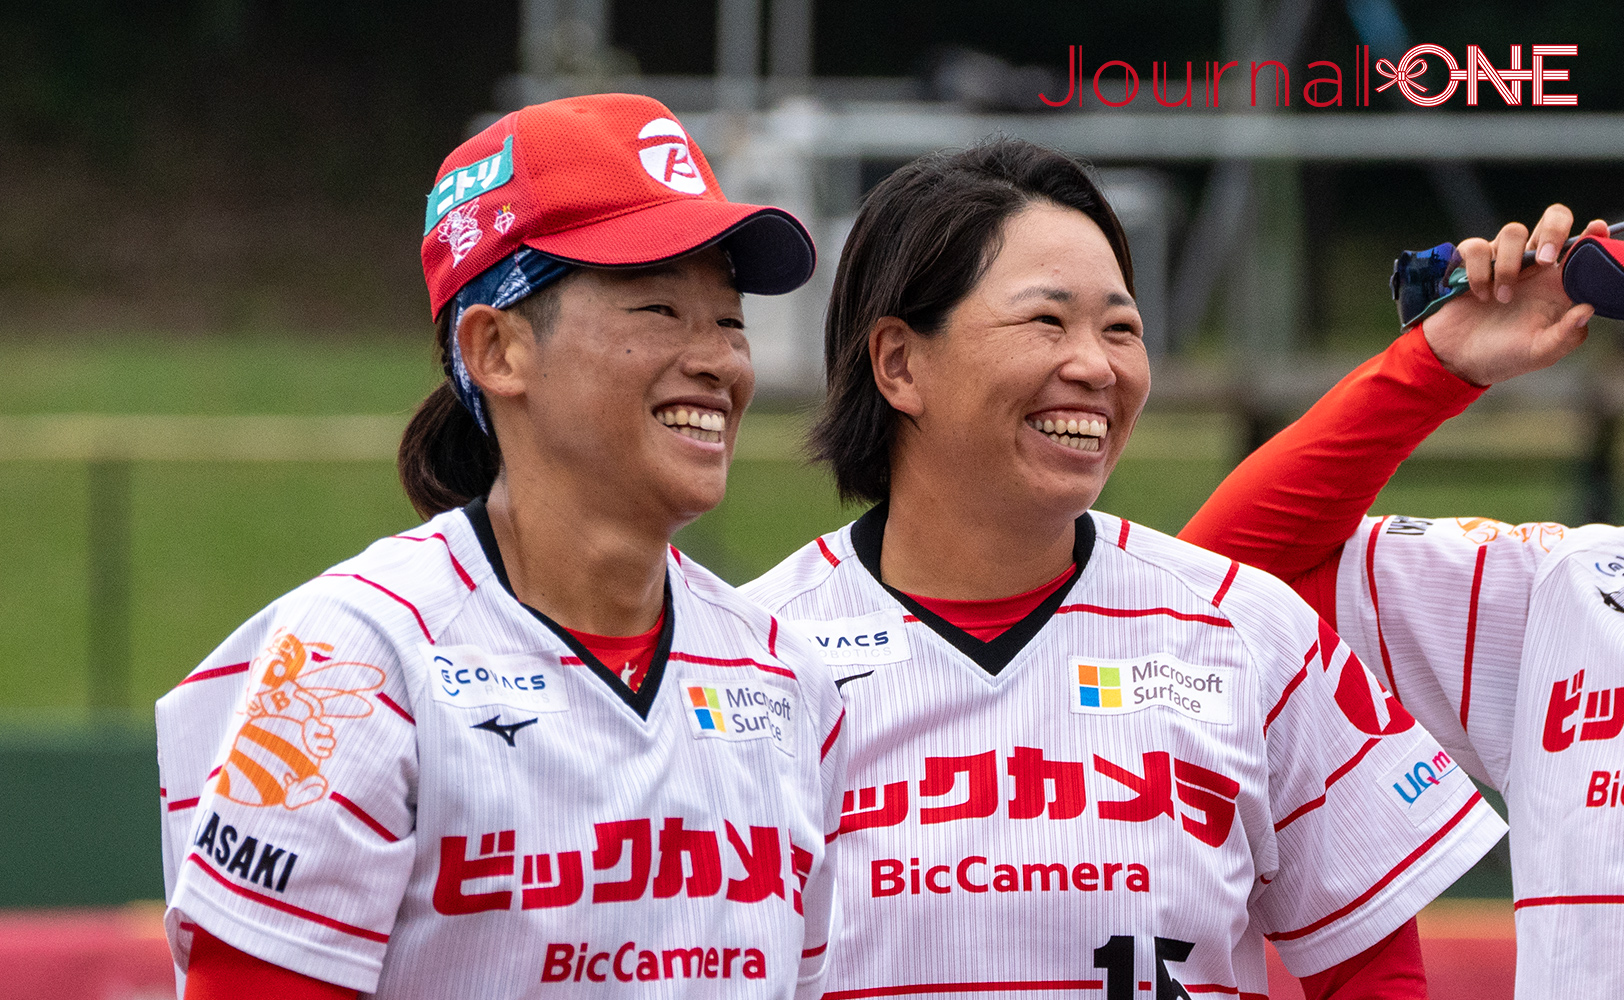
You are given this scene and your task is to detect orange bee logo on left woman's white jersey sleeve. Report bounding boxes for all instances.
[218,630,383,808]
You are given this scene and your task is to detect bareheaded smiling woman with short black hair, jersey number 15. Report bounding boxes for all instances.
[745,140,1504,1000]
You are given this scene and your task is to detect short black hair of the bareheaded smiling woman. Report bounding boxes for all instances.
[810,138,1134,503]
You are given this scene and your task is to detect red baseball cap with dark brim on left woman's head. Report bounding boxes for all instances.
[422,94,817,315]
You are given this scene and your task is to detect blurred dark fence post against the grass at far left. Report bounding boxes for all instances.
[86,458,130,709]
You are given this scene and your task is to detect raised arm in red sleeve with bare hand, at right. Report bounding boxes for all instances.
[1179,205,1606,617]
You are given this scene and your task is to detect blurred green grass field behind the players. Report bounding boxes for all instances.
[0,338,1598,716]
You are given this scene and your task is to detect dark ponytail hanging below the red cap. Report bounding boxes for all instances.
[396,308,502,521]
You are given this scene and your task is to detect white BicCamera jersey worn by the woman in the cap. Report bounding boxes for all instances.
[158,505,844,998]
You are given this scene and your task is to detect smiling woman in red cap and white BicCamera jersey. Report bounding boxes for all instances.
[158,96,843,1000]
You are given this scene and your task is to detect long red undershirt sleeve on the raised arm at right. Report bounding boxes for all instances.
[1179,326,1484,583]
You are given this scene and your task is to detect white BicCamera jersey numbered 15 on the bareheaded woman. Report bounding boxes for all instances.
[744,508,1505,1000]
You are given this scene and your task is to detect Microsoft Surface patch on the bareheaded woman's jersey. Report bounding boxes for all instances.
[1070,653,1234,726]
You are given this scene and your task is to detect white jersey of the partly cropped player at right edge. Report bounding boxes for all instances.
[1337,518,1624,997]
